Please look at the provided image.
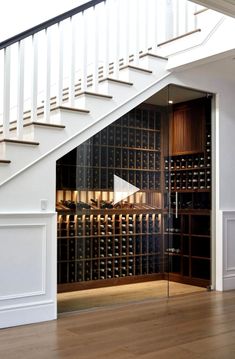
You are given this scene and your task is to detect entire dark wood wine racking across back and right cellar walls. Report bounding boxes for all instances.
[56,98,211,291]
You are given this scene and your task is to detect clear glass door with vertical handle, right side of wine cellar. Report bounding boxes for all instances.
[163,85,211,296]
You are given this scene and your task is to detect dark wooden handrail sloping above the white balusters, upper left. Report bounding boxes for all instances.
[0,0,106,50]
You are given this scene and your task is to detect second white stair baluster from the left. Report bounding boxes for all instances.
[16,40,24,139]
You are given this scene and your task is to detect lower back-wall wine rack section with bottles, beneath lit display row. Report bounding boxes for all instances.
[58,214,160,284]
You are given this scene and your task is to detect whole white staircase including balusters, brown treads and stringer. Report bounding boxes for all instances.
[0,0,207,185]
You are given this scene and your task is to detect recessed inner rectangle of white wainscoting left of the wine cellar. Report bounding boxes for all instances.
[0,223,46,301]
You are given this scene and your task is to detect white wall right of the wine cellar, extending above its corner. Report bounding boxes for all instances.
[170,59,235,290]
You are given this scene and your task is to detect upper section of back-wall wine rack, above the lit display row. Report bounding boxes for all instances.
[57,109,161,191]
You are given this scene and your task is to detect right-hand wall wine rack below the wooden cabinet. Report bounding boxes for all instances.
[163,107,211,287]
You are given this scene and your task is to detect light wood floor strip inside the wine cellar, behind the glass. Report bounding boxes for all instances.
[57,280,205,313]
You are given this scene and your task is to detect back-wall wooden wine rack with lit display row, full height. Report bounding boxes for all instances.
[56,107,163,291]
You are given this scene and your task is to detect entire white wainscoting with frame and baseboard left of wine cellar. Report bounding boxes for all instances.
[0,212,57,328]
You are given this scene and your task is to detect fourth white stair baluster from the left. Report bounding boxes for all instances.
[44,28,51,122]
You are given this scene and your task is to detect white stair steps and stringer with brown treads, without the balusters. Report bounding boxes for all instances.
[0,54,168,184]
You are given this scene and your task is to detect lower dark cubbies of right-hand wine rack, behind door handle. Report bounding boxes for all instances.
[164,210,211,286]
